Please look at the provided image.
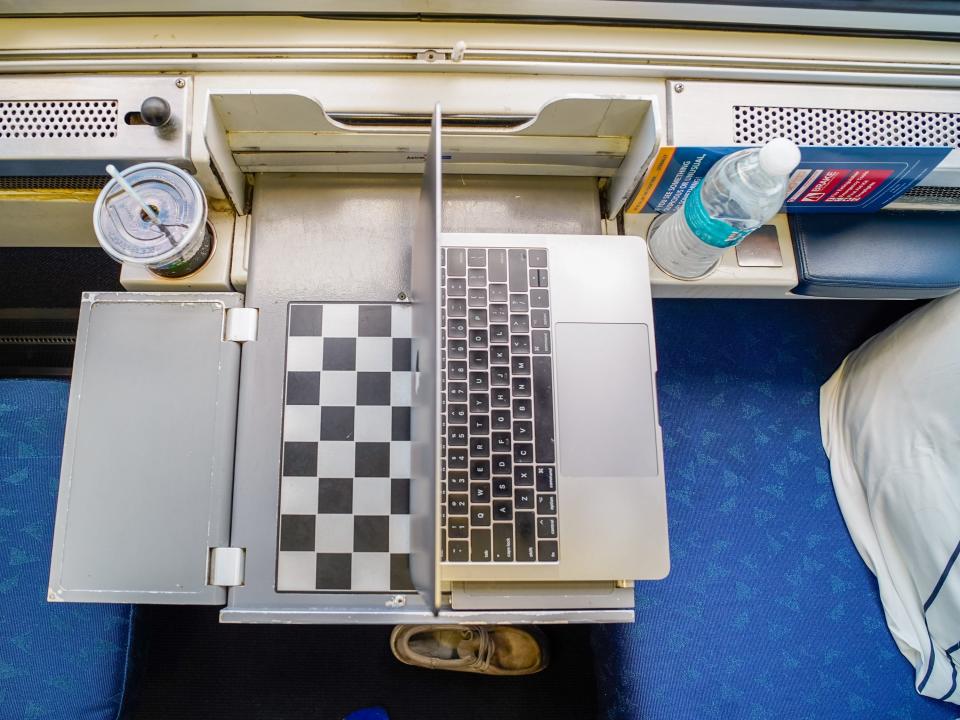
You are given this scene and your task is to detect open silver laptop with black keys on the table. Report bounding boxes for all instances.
[411,102,669,607]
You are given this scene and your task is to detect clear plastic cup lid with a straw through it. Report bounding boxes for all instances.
[93,163,207,265]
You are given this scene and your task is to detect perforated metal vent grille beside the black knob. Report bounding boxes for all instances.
[0,100,119,141]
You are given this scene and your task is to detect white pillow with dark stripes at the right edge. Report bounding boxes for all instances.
[820,293,960,704]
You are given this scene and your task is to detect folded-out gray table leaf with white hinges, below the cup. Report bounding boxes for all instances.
[48,293,243,604]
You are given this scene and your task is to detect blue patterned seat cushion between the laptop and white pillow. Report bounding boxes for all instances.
[593,300,960,720]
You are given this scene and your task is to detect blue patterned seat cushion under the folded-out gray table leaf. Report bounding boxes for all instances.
[0,380,133,720]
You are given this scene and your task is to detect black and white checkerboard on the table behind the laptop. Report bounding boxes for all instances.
[277,303,413,592]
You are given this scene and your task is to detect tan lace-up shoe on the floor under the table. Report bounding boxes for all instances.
[390,625,549,675]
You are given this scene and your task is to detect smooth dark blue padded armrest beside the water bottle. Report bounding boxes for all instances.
[790,210,960,299]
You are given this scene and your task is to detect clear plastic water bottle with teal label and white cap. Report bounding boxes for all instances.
[649,138,800,280]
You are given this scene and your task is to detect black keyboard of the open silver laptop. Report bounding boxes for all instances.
[440,248,559,563]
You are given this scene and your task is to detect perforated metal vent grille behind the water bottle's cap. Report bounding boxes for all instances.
[733,105,960,148]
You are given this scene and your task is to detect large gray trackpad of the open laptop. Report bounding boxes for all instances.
[555,323,657,477]
